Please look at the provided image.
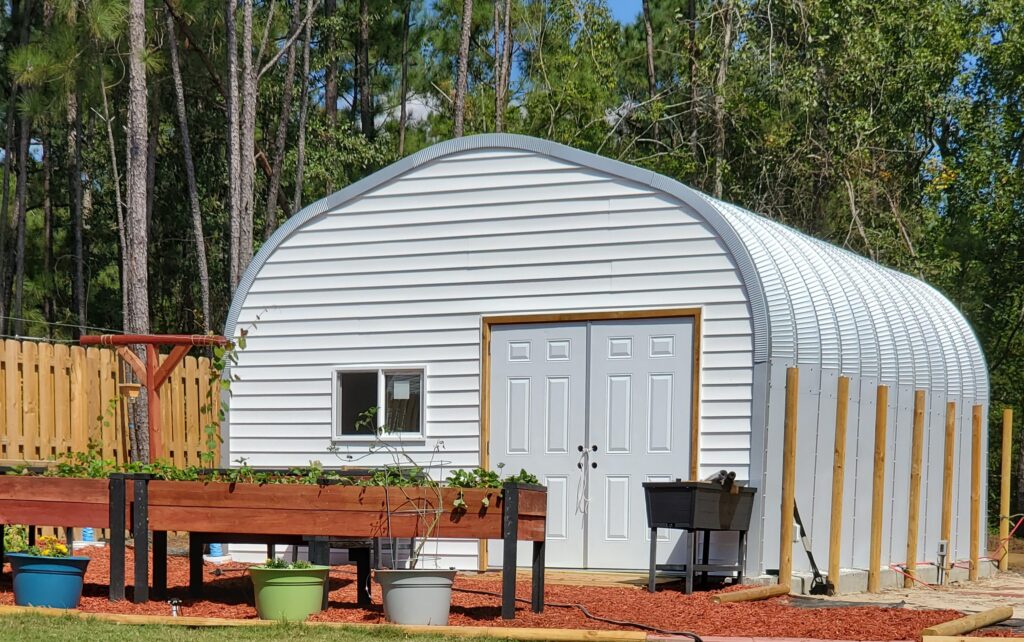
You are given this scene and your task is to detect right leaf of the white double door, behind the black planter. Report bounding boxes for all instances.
[587,318,693,568]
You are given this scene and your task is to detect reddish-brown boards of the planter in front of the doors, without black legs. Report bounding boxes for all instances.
[148,480,547,542]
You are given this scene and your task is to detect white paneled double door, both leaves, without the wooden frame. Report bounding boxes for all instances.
[488,317,694,568]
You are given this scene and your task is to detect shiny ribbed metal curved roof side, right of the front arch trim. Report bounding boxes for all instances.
[705,197,988,401]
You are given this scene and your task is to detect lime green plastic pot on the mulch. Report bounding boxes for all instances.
[249,565,330,622]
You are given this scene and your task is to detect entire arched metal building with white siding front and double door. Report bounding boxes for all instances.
[222,134,988,574]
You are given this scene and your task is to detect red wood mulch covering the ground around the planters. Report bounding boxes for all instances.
[0,549,961,640]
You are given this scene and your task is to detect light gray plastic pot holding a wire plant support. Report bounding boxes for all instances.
[375,568,456,627]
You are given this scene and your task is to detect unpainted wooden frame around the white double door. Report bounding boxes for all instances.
[479,307,702,570]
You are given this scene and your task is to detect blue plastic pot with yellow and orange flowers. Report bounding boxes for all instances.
[7,553,89,608]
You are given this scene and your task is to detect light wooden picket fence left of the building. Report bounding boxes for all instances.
[0,339,220,466]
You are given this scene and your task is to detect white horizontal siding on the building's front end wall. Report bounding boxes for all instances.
[226,148,754,567]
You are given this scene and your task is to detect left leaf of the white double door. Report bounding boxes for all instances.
[487,323,587,568]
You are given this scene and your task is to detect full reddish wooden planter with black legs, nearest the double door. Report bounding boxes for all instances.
[132,475,548,619]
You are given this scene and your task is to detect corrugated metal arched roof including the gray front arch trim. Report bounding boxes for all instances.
[224,134,988,400]
